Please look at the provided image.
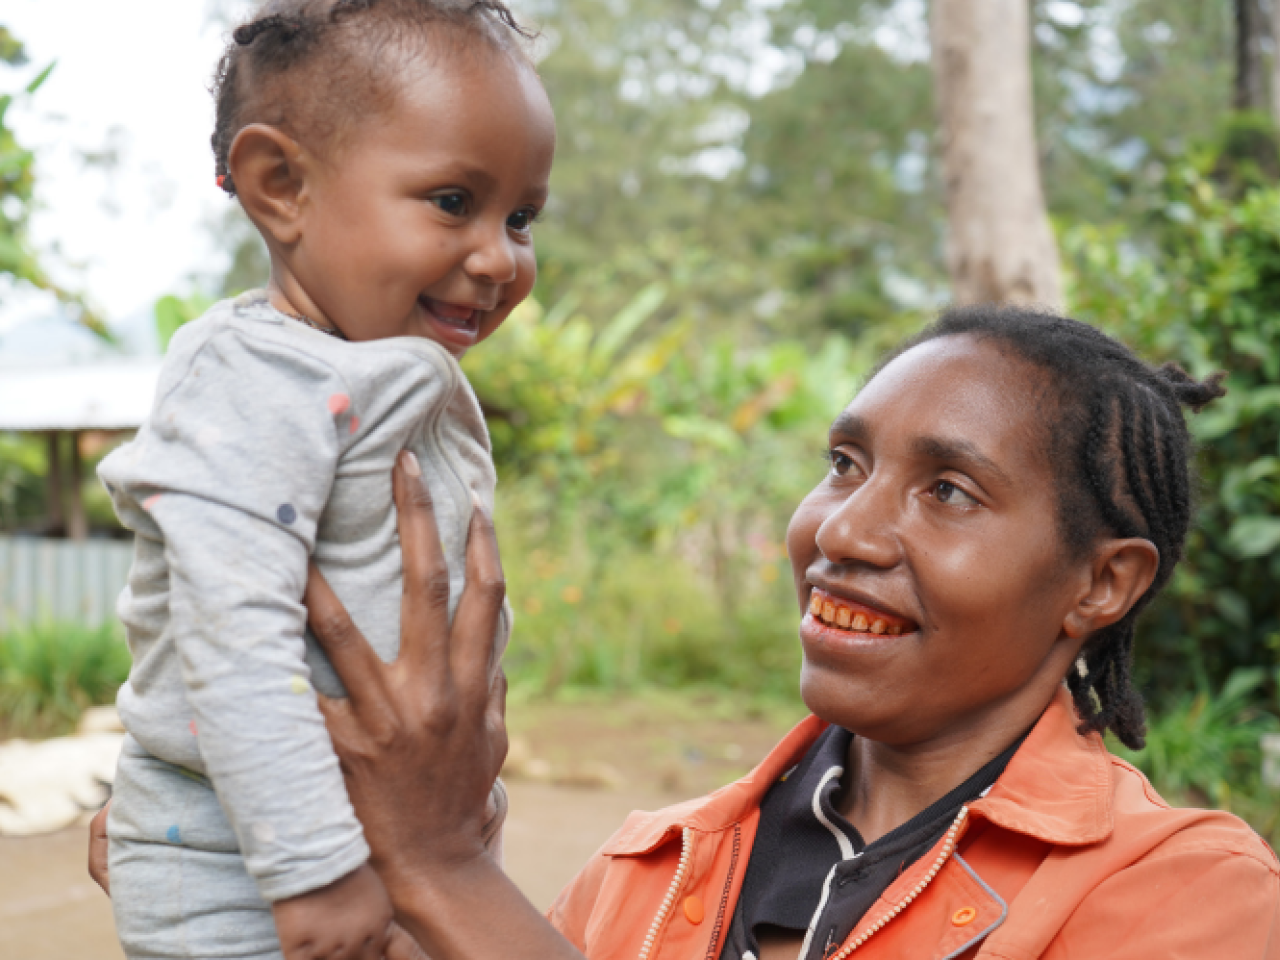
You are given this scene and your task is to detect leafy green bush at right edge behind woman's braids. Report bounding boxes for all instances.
[1064,160,1280,700]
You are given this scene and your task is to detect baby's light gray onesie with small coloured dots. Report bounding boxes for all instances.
[99,291,509,957]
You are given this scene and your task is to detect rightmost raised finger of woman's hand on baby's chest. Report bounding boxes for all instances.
[452,500,507,704]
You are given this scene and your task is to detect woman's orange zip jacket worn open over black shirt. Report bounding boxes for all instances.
[548,690,1280,960]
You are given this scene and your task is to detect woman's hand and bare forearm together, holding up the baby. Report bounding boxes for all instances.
[306,453,581,960]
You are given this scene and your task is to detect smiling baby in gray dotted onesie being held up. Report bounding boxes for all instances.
[100,0,556,960]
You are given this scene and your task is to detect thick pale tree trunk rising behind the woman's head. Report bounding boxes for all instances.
[932,0,1062,308]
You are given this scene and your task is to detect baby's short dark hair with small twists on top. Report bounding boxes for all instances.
[212,0,535,195]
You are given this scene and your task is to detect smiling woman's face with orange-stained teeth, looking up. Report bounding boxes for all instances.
[787,337,1089,746]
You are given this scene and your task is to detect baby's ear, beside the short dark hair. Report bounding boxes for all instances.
[227,123,308,247]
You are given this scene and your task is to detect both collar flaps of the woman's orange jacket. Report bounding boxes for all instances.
[602,687,1114,856]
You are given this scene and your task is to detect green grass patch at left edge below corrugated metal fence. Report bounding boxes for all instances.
[0,623,129,736]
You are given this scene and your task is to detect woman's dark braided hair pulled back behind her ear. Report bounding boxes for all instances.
[886,306,1226,750]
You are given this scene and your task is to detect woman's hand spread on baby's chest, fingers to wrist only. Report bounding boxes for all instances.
[305,452,507,901]
